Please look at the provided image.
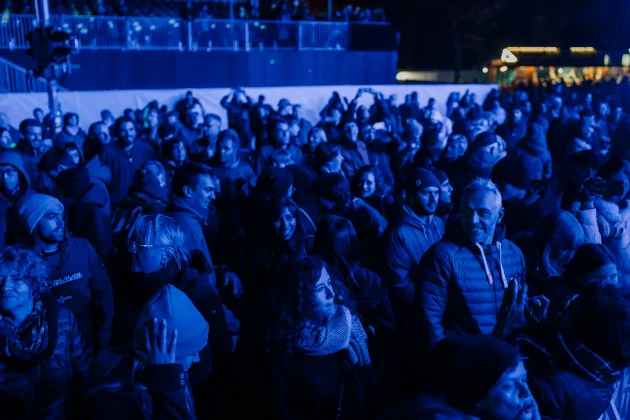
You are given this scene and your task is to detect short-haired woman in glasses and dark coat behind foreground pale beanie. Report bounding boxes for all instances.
[114,214,232,416]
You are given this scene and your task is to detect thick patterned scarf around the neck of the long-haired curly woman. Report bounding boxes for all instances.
[295,305,371,367]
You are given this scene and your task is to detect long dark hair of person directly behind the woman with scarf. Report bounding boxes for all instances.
[313,215,361,290]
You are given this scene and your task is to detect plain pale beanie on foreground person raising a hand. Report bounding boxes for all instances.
[133,284,210,357]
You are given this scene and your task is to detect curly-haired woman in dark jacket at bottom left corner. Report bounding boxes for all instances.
[0,246,85,419]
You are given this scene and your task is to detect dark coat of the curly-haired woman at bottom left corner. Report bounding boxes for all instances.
[0,294,85,420]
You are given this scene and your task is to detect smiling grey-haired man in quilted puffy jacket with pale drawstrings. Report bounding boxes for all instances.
[415,178,525,347]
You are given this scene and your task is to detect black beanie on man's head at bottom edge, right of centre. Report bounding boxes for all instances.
[433,335,519,412]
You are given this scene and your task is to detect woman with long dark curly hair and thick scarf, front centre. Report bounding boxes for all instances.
[265,257,376,418]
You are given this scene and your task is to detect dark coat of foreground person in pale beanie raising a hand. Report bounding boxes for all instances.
[85,355,195,420]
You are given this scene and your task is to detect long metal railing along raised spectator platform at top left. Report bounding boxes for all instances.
[0,15,350,51]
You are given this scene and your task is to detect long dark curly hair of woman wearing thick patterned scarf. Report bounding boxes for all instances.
[267,257,354,352]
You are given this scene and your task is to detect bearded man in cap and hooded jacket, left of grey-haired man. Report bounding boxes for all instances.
[384,168,444,316]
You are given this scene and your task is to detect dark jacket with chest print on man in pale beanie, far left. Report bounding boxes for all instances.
[36,236,114,349]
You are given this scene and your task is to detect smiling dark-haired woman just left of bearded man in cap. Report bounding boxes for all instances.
[352,165,396,220]
